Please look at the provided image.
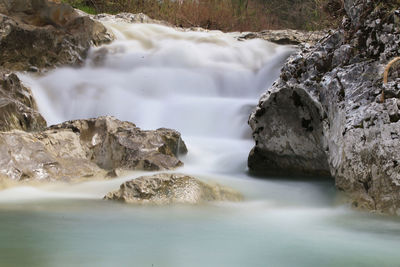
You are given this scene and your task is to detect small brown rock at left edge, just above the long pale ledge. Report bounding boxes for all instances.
[0,71,46,131]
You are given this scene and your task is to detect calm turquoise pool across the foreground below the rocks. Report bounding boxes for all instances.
[0,183,400,267]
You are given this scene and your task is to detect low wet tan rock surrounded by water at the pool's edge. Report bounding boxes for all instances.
[104,173,243,205]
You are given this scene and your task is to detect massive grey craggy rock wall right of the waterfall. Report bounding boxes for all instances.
[248,0,400,215]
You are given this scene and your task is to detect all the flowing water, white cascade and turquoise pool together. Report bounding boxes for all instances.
[0,22,400,267]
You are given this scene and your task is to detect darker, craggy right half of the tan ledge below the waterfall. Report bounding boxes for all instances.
[50,116,187,171]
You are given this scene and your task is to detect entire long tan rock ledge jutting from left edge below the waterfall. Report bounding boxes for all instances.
[0,117,186,181]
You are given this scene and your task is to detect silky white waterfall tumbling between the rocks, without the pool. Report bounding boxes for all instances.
[23,22,294,176]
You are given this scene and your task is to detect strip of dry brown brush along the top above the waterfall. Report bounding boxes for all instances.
[64,0,343,31]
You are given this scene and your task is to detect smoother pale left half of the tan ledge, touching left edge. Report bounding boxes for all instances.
[0,130,105,181]
